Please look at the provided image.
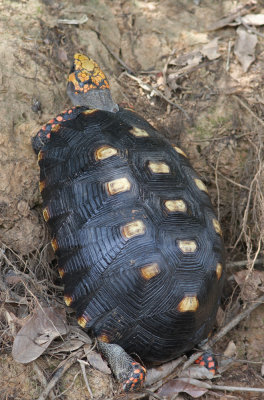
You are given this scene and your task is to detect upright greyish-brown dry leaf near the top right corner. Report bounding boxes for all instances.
[234,27,258,72]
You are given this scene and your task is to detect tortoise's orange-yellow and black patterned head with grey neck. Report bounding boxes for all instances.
[67,53,119,112]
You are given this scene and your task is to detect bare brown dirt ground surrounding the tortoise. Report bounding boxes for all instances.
[0,0,264,400]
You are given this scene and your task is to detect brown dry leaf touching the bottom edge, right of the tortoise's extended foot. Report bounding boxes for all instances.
[158,379,210,400]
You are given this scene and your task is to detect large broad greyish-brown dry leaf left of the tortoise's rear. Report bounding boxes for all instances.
[12,307,67,364]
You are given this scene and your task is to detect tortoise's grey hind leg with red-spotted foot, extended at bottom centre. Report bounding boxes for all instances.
[98,341,146,392]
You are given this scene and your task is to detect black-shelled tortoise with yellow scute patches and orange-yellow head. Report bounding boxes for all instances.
[32,53,225,391]
